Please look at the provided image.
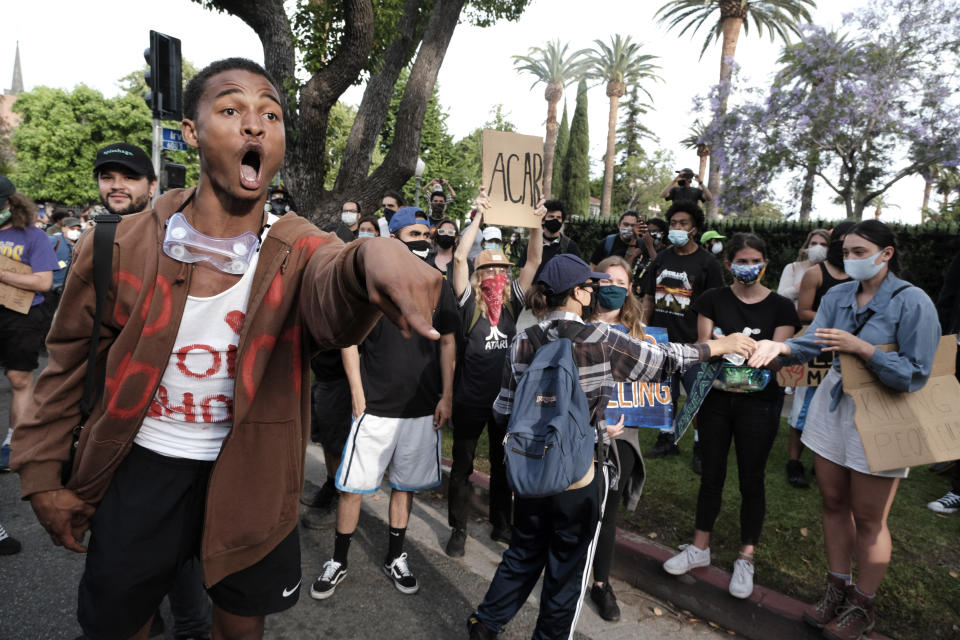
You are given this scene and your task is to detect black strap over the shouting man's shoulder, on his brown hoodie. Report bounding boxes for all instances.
[80,213,122,424]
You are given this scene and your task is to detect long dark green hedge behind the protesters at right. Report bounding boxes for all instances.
[565,217,960,300]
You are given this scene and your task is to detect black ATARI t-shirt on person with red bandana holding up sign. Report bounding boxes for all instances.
[453,280,523,408]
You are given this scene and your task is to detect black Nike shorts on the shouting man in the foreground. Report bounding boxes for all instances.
[77,446,300,640]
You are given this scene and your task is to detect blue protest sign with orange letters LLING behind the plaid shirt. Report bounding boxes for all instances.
[606,325,673,429]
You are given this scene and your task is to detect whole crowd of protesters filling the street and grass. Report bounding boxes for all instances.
[0,59,948,639]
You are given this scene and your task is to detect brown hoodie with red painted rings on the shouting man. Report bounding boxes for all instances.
[12,190,379,585]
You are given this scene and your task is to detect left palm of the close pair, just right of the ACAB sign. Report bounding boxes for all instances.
[513,40,588,197]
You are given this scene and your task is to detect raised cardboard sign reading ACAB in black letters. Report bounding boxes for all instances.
[482,129,543,228]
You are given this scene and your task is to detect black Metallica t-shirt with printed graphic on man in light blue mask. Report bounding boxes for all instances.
[643,246,723,343]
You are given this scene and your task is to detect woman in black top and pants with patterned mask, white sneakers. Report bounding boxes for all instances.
[663,233,800,598]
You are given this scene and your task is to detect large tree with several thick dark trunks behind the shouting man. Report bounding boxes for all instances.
[195,0,530,222]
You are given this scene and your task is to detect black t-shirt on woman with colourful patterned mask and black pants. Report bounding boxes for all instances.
[693,287,800,397]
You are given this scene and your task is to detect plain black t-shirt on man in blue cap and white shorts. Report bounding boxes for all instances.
[360,278,459,418]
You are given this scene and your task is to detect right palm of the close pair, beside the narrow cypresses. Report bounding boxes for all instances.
[589,34,661,216]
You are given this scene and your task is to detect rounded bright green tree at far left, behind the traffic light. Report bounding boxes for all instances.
[12,85,151,206]
